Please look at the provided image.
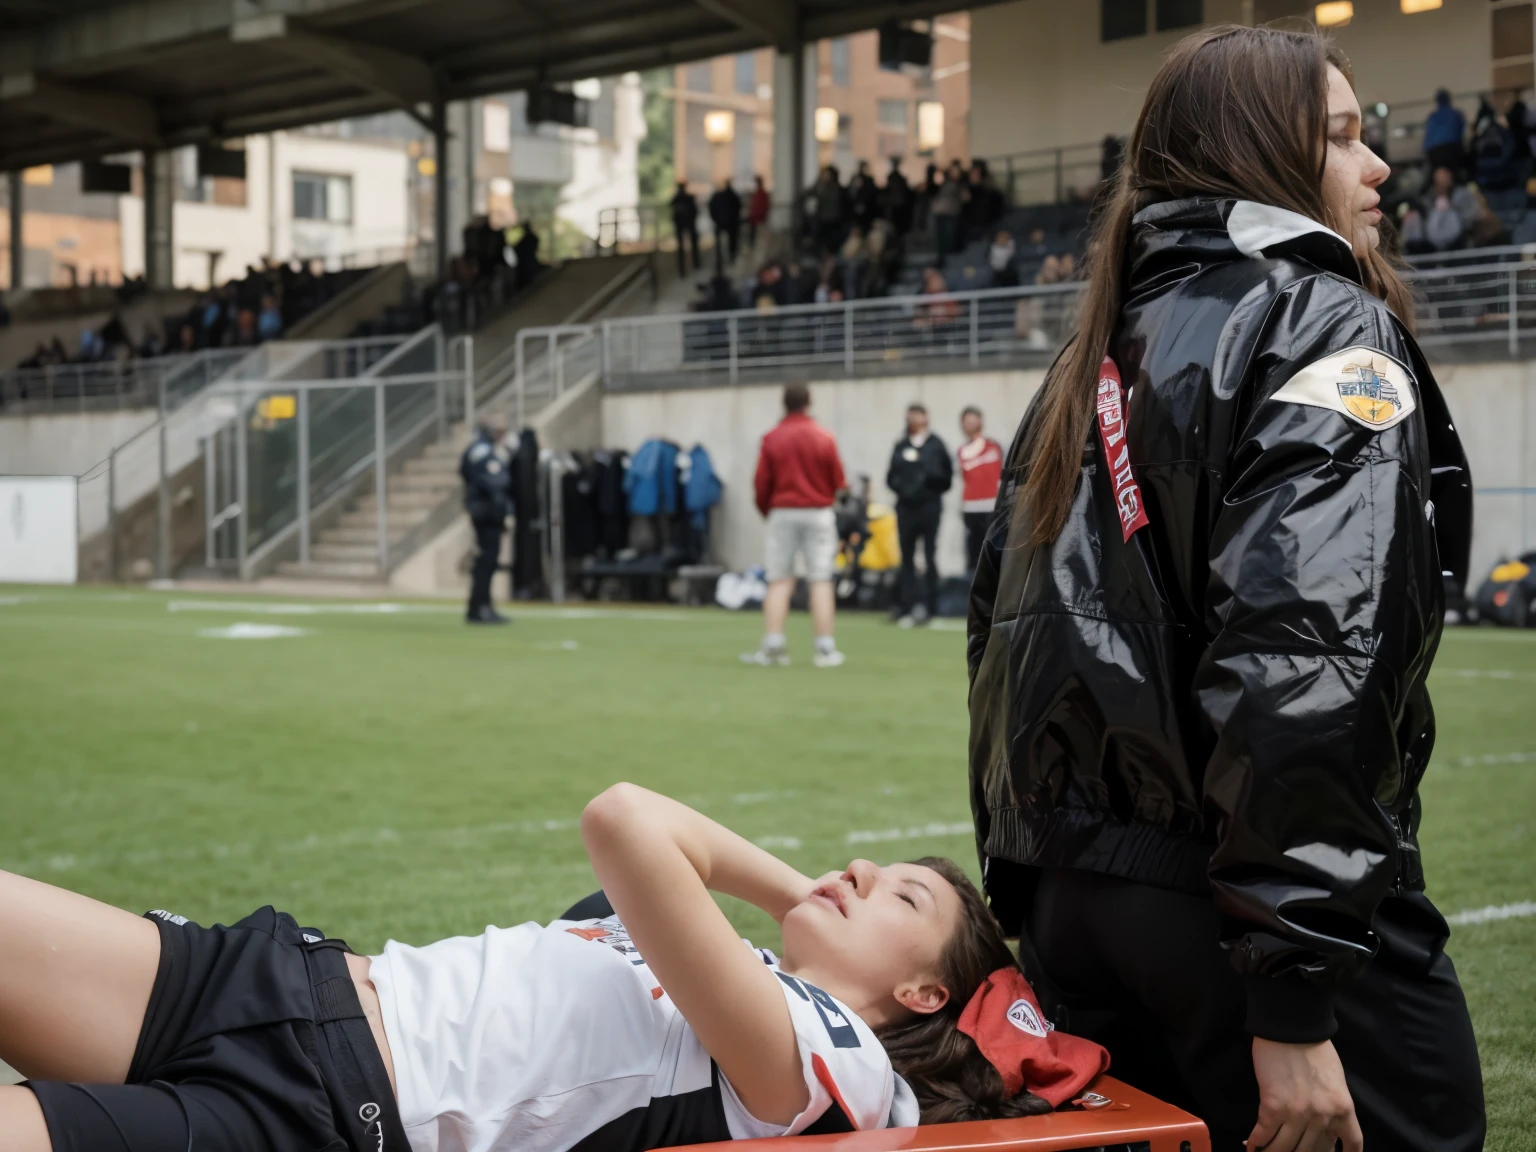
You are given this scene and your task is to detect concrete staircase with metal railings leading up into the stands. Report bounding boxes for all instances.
[276,257,650,582]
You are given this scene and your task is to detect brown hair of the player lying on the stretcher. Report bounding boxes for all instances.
[879,856,1051,1124]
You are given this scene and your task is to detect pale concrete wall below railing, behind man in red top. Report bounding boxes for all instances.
[602,370,1044,576]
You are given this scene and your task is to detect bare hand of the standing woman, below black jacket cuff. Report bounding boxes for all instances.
[1247,1037,1366,1152]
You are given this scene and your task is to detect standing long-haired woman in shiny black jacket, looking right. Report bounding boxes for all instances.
[968,26,1485,1152]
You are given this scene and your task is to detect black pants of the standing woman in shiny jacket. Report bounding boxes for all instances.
[1031,869,1485,1152]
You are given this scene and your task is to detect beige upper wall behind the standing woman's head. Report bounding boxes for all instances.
[971,0,1491,157]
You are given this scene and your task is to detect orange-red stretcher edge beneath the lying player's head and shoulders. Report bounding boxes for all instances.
[693,1077,1210,1152]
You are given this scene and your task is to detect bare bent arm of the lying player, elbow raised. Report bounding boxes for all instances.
[581,783,814,1124]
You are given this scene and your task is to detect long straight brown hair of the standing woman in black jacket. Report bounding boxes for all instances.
[1020,25,1413,544]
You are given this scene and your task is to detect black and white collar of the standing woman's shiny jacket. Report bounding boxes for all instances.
[1127,200,1361,292]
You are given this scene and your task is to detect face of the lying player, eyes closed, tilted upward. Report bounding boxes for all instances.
[783,860,962,1026]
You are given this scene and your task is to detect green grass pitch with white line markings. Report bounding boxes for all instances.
[0,588,1536,1149]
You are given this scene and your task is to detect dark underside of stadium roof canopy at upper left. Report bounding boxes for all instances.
[0,0,991,170]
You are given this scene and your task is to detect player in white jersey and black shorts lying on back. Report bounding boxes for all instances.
[0,785,1107,1152]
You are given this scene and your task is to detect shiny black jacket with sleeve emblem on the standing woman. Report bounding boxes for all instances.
[968,200,1471,1040]
